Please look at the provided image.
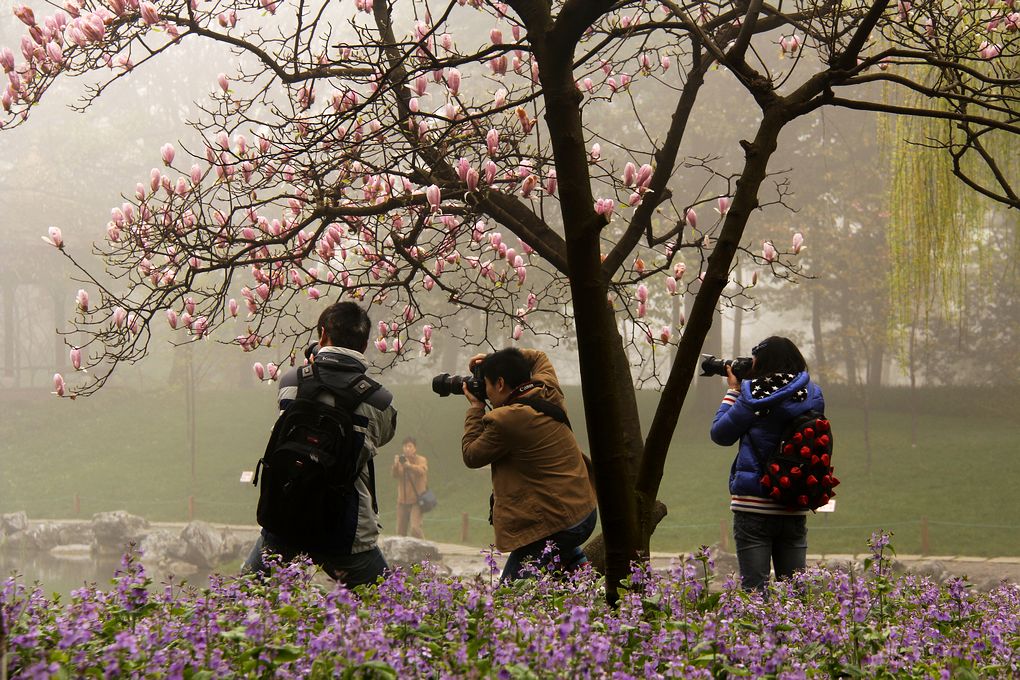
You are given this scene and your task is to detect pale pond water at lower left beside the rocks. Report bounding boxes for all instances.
[0,548,217,597]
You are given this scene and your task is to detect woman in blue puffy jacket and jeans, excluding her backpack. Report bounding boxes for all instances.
[712,335,825,590]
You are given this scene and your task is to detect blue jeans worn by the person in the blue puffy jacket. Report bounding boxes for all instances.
[733,511,808,590]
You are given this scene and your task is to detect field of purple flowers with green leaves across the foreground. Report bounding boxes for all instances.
[0,535,1020,679]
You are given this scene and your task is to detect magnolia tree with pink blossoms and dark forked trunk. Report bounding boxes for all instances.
[0,0,1020,596]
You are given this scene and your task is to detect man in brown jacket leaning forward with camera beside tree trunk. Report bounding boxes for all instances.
[462,348,596,580]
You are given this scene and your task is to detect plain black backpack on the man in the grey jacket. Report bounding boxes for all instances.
[252,360,380,550]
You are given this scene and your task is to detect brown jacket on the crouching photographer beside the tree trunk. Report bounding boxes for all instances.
[462,350,595,551]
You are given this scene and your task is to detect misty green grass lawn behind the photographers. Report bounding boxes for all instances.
[0,385,1020,556]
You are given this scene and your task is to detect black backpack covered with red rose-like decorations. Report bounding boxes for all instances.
[761,410,839,510]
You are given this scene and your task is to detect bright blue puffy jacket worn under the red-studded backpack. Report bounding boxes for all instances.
[712,371,825,498]
